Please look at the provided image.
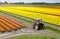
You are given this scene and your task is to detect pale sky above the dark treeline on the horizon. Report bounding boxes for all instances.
[0,0,60,3]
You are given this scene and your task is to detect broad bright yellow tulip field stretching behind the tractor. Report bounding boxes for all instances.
[0,6,60,26]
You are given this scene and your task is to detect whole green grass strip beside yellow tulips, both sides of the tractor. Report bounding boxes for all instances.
[0,11,60,34]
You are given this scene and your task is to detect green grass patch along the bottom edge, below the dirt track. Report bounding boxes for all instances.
[10,35,57,39]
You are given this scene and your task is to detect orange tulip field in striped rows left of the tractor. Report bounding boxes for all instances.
[0,15,23,32]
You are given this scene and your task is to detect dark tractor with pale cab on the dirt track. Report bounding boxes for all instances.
[33,19,44,30]
